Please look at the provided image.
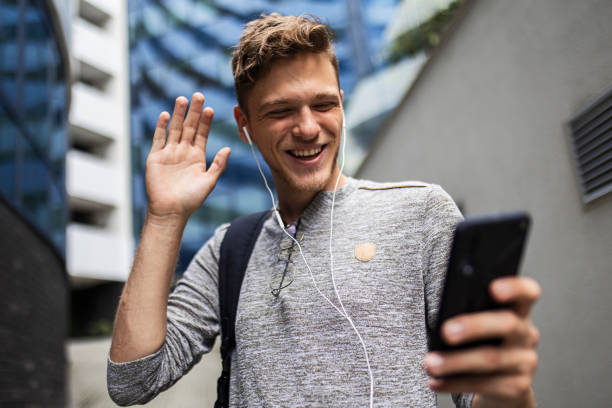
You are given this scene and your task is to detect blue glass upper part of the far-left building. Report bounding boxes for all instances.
[0,0,68,253]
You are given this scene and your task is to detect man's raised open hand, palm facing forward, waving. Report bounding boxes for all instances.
[145,92,230,221]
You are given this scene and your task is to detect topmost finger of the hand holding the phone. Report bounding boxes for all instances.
[490,276,542,317]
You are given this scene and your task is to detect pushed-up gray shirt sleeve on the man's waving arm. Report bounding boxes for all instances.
[107,224,228,406]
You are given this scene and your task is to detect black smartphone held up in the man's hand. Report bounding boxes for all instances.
[430,212,531,350]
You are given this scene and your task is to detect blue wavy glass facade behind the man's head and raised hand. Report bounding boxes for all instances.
[128,0,398,271]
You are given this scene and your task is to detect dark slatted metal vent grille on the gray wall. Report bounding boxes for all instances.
[568,88,612,204]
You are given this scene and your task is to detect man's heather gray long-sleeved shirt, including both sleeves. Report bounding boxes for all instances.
[108,179,471,408]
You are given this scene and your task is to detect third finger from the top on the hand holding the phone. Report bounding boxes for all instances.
[424,346,538,377]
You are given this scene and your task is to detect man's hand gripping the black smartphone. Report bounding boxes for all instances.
[425,277,540,408]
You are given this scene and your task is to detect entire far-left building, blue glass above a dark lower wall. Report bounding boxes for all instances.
[0,1,70,407]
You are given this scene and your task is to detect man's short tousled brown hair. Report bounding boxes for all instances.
[232,13,340,113]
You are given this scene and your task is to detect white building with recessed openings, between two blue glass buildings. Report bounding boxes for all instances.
[66,0,134,336]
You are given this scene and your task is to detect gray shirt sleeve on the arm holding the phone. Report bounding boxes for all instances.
[423,185,473,408]
